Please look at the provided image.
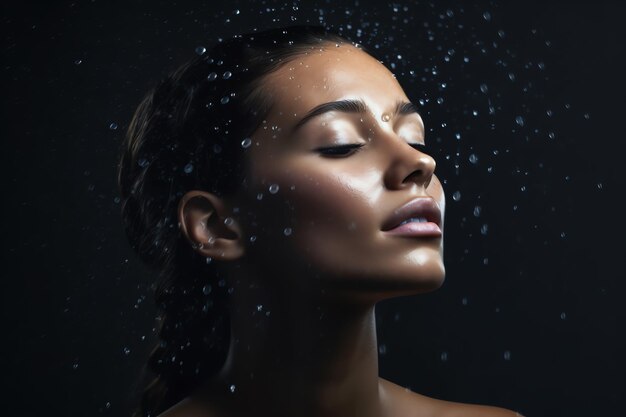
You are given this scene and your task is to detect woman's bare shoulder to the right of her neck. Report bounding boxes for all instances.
[380,378,523,417]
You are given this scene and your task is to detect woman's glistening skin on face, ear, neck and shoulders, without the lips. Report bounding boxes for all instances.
[173,44,515,417]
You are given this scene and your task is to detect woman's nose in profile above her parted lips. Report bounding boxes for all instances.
[384,139,437,190]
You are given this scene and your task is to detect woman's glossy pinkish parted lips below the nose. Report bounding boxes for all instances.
[382,197,442,237]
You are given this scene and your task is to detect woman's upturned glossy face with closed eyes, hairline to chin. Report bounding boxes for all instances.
[235,44,445,295]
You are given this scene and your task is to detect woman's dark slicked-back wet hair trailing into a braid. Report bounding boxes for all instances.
[118,26,347,417]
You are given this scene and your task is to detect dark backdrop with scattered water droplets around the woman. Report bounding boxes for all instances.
[0,0,626,416]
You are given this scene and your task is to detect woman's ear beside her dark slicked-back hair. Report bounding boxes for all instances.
[178,190,245,261]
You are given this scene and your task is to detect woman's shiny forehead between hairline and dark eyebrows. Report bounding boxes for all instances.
[265,44,408,124]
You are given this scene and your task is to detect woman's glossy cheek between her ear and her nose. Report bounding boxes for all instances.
[243,158,383,271]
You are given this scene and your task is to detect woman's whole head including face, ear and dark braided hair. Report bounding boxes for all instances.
[119,27,444,412]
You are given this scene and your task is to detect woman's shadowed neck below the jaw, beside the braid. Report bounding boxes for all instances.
[195,264,382,417]
